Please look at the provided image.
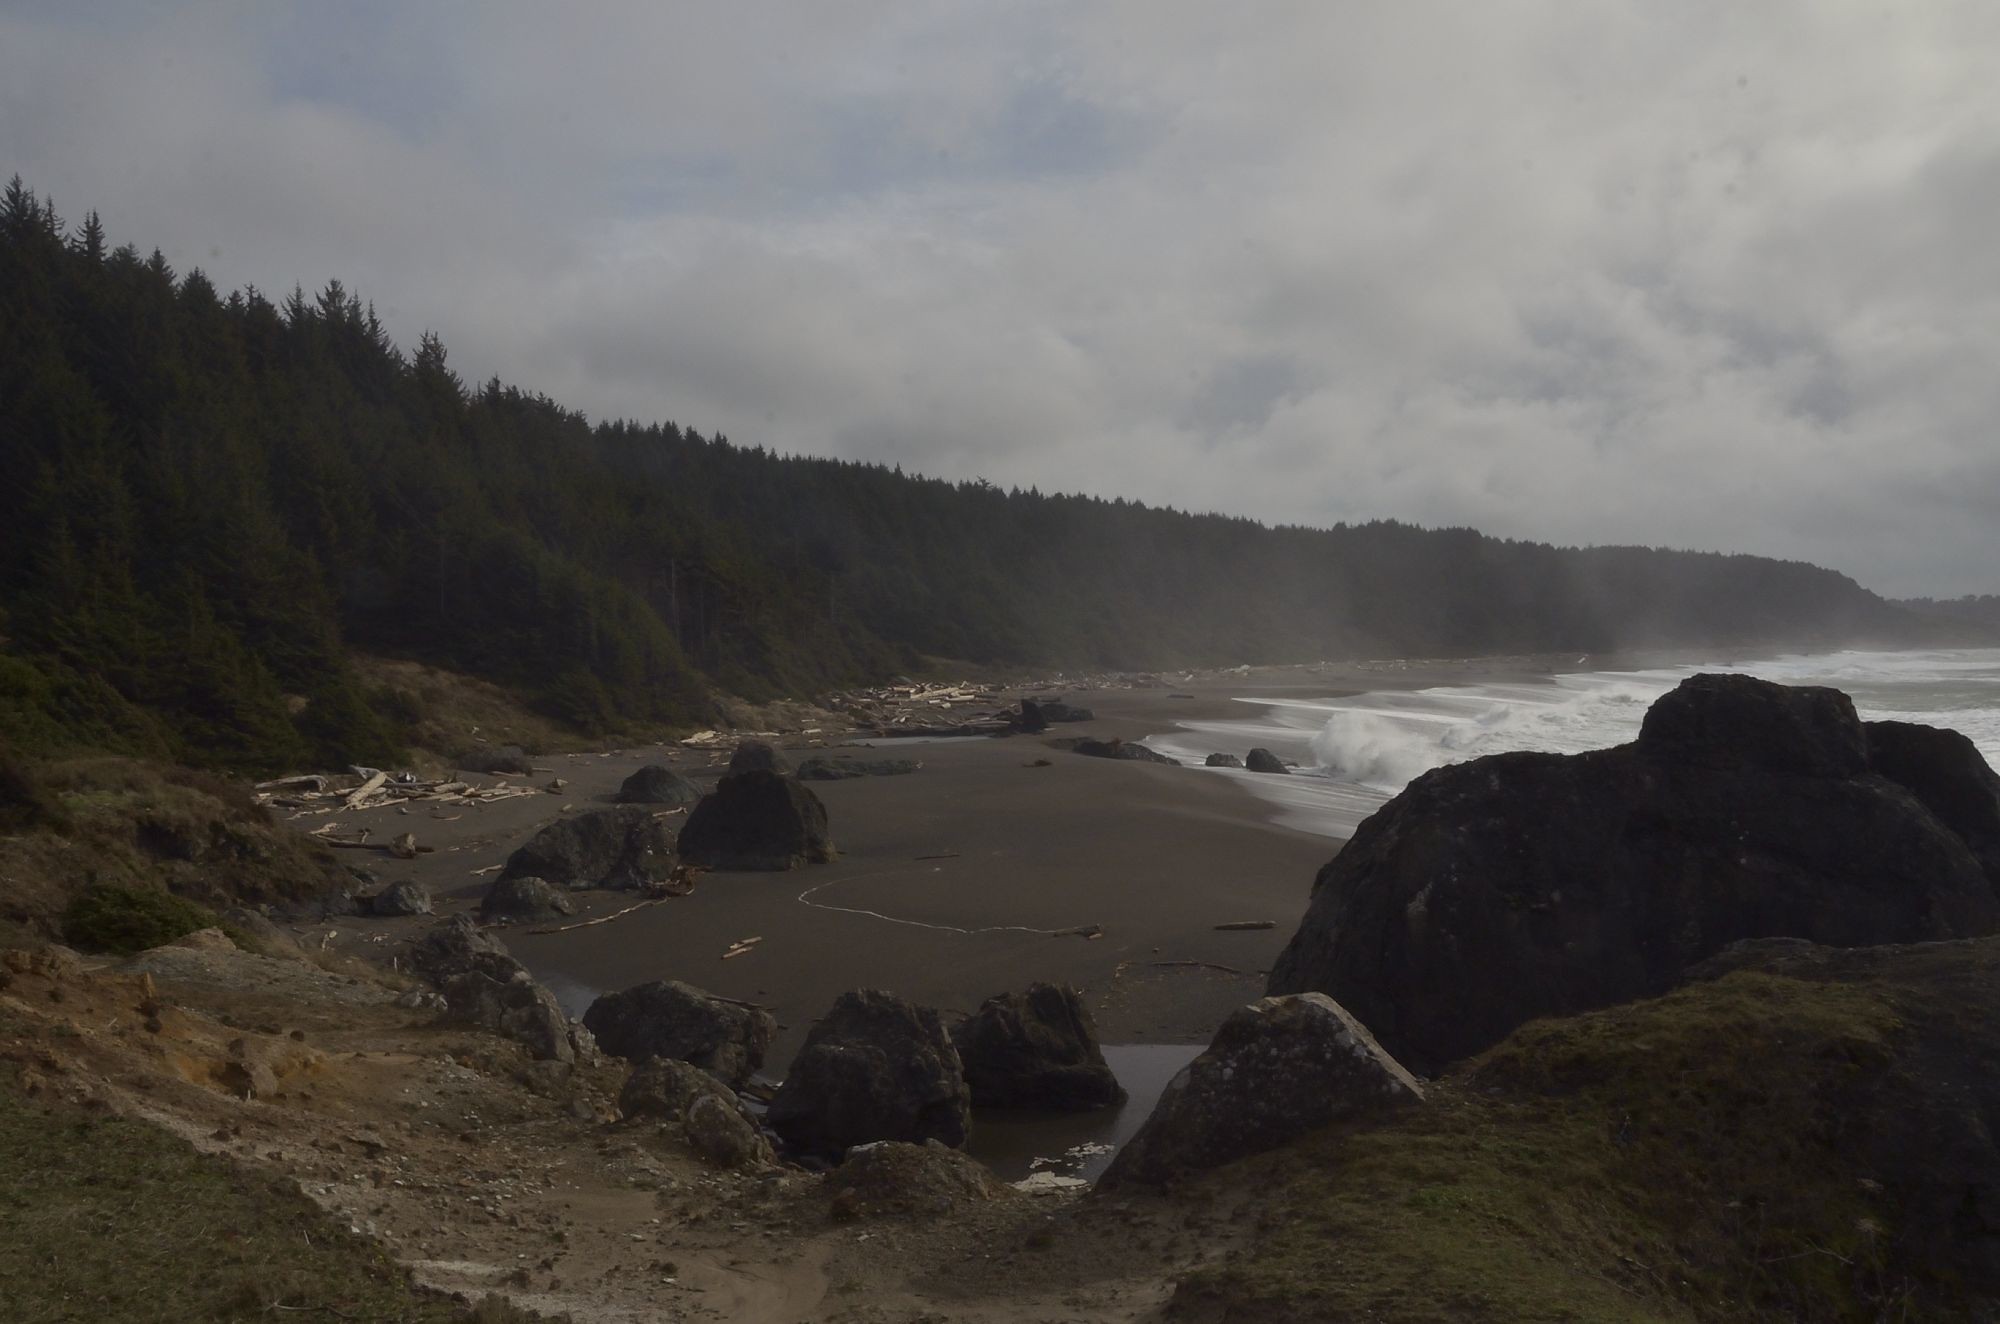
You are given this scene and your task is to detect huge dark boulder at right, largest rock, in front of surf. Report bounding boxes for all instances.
[1268,676,2000,1074]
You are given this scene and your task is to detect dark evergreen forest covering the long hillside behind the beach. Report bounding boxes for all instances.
[0,178,1956,770]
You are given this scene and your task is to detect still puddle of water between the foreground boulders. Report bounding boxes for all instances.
[966,1044,1206,1182]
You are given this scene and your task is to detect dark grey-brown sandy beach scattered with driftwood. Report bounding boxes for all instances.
[320,658,1600,1068]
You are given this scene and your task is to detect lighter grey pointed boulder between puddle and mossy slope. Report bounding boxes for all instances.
[1098,994,1424,1188]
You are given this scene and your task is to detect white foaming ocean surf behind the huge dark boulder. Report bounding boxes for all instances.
[1146,648,2000,836]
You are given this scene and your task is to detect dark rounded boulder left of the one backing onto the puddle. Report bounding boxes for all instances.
[764,988,972,1160]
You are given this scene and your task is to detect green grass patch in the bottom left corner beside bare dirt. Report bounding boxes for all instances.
[0,1068,508,1324]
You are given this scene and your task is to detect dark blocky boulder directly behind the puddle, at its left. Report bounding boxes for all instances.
[952,984,1126,1112]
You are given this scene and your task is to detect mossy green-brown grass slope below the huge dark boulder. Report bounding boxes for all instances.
[1178,972,1934,1324]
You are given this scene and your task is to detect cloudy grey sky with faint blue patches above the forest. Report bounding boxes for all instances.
[0,0,2000,596]
